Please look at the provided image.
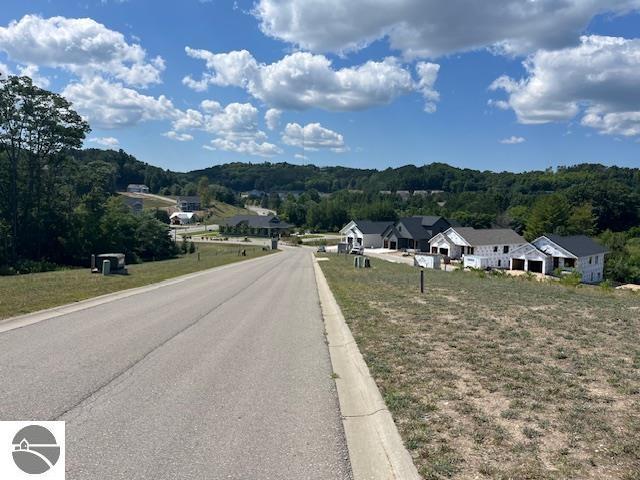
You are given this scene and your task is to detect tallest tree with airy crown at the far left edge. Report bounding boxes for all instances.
[0,76,90,261]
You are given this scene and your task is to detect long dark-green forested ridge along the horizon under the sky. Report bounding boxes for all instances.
[73,149,640,203]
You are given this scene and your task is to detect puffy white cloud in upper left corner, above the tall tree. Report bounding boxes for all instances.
[0,15,165,86]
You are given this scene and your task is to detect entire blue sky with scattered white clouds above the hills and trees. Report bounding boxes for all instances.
[0,0,640,171]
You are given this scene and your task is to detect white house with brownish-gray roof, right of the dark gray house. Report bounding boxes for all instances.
[429,227,527,268]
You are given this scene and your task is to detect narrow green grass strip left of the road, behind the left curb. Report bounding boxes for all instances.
[0,244,270,319]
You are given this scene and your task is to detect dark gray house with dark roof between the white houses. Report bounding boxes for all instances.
[382,215,451,252]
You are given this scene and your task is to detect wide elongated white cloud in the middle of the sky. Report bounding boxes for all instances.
[183,47,438,111]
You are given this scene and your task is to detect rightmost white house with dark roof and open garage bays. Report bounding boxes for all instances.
[509,234,607,283]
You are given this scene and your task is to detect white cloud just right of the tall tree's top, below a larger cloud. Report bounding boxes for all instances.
[62,77,180,129]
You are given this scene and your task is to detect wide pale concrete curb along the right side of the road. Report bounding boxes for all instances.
[313,258,421,480]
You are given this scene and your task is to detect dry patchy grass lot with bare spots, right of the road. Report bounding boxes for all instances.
[320,255,640,480]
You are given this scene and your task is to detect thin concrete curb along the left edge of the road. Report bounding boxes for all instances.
[0,252,279,333]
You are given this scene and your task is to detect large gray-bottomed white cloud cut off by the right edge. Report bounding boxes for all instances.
[490,36,640,136]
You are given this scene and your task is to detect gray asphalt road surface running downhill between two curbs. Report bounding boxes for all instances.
[0,249,351,480]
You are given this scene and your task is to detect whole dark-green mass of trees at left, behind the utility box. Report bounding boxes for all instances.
[0,76,176,274]
